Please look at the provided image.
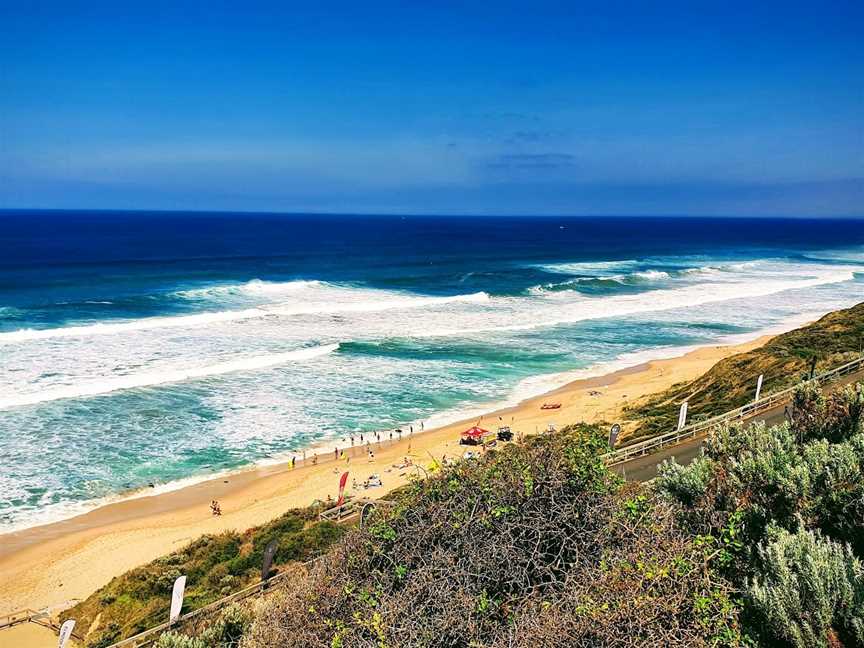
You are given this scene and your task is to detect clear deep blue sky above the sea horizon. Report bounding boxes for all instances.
[0,0,864,216]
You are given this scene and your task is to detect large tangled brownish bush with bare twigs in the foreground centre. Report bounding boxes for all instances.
[242,425,741,648]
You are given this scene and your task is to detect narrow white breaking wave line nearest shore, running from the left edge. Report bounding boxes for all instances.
[0,344,339,409]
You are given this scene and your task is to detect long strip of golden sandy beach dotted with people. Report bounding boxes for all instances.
[0,337,769,616]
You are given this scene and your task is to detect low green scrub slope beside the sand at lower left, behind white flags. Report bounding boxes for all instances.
[62,507,345,648]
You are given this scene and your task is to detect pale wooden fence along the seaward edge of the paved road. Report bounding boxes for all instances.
[603,356,864,466]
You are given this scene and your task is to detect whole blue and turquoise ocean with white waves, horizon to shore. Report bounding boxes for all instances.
[0,211,864,531]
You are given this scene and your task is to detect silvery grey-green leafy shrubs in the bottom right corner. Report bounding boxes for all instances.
[656,384,864,648]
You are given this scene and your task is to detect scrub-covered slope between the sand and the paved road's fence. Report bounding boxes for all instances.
[624,303,864,442]
